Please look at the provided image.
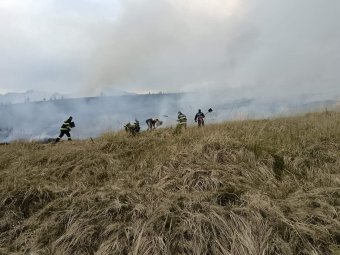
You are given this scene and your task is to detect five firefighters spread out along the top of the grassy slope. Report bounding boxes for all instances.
[55,108,212,143]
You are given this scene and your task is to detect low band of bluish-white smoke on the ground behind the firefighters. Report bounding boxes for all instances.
[0,91,336,142]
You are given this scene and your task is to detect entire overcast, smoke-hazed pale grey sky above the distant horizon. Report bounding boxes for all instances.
[0,0,340,94]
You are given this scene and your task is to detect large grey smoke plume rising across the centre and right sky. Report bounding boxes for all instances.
[83,0,340,96]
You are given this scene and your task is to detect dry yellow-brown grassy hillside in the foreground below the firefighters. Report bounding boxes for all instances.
[0,112,340,255]
